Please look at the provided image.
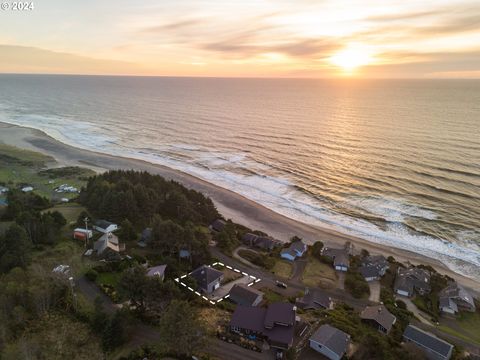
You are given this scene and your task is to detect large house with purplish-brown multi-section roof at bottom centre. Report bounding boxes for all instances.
[230,303,296,350]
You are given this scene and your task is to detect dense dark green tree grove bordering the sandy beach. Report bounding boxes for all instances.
[80,170,219,228]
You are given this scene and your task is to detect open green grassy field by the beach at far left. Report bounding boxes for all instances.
[0,144,95,200]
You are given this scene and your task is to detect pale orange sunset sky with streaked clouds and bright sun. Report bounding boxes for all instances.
[0,0,480,78]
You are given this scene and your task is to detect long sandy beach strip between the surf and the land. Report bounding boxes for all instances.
[0,121,480,296]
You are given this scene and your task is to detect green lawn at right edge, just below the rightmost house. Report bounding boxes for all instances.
[438,311,480,346]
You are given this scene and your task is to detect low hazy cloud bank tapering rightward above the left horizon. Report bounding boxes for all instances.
[0,45,141,74]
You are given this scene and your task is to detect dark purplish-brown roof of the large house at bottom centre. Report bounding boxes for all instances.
[230,303,295,344]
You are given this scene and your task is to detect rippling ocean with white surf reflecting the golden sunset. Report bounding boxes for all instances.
[0,75,480,277]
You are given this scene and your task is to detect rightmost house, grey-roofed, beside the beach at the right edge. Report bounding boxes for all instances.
[438,282,476,315]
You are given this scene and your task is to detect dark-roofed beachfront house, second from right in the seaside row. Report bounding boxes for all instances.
[394,267,430,297]
